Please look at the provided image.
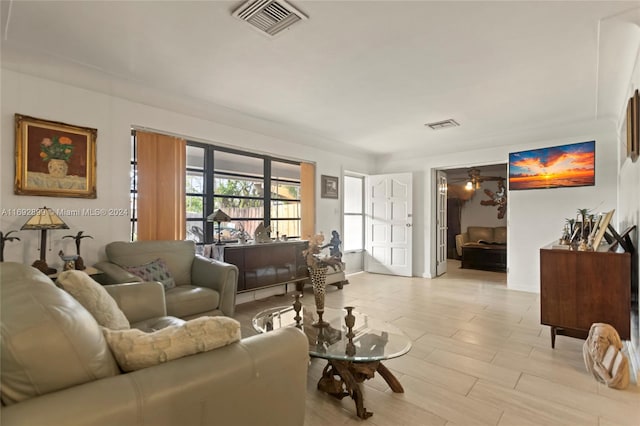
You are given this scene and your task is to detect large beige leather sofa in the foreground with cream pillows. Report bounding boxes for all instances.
[0,263,308,426]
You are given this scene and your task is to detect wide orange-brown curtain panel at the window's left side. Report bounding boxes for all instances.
[136,131,187,241]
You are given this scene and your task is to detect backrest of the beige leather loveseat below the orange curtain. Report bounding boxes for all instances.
[105,241,196,286]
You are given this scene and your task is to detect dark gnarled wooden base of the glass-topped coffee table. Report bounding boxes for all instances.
[318,360,404,419]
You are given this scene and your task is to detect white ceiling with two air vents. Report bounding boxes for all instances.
[1,0,640,154]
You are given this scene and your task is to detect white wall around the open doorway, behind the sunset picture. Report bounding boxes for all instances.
[377,121,618,292]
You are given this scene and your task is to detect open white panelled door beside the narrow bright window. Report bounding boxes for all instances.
[365,173,413,277]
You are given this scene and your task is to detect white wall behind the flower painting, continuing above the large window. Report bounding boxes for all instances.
[0,69,373,268]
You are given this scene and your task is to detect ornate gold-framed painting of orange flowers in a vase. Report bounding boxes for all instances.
[14,114,98,198]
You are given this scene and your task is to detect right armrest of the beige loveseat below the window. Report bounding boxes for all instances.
[191,256,238,317]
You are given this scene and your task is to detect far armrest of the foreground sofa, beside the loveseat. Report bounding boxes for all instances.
[104,282,167,323]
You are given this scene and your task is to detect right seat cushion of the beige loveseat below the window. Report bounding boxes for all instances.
[165,285,220,317]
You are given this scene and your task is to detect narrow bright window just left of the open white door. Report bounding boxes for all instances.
[343,175,364,252]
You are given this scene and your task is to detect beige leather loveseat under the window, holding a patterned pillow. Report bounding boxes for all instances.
[95,241,238,319]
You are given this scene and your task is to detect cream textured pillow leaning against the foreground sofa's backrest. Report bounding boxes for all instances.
[56,271,130,330]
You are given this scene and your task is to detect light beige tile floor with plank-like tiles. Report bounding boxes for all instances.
[236,261,640,426]
